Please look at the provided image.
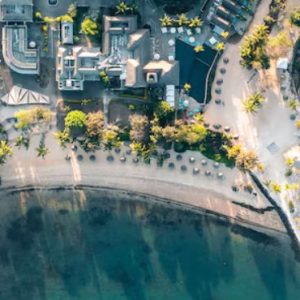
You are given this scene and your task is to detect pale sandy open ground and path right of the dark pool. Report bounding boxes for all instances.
[205,1,300,240]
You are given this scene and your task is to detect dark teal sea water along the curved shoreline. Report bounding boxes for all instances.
[0,190,300,300]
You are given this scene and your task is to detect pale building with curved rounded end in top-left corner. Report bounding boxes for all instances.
[0,0,39,75]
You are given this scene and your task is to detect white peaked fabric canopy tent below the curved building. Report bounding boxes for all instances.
[1,85,50,105]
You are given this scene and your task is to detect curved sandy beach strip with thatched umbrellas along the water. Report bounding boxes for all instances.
[0,135,286,237]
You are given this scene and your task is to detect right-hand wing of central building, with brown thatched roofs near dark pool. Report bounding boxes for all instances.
[100,16,179,88]
